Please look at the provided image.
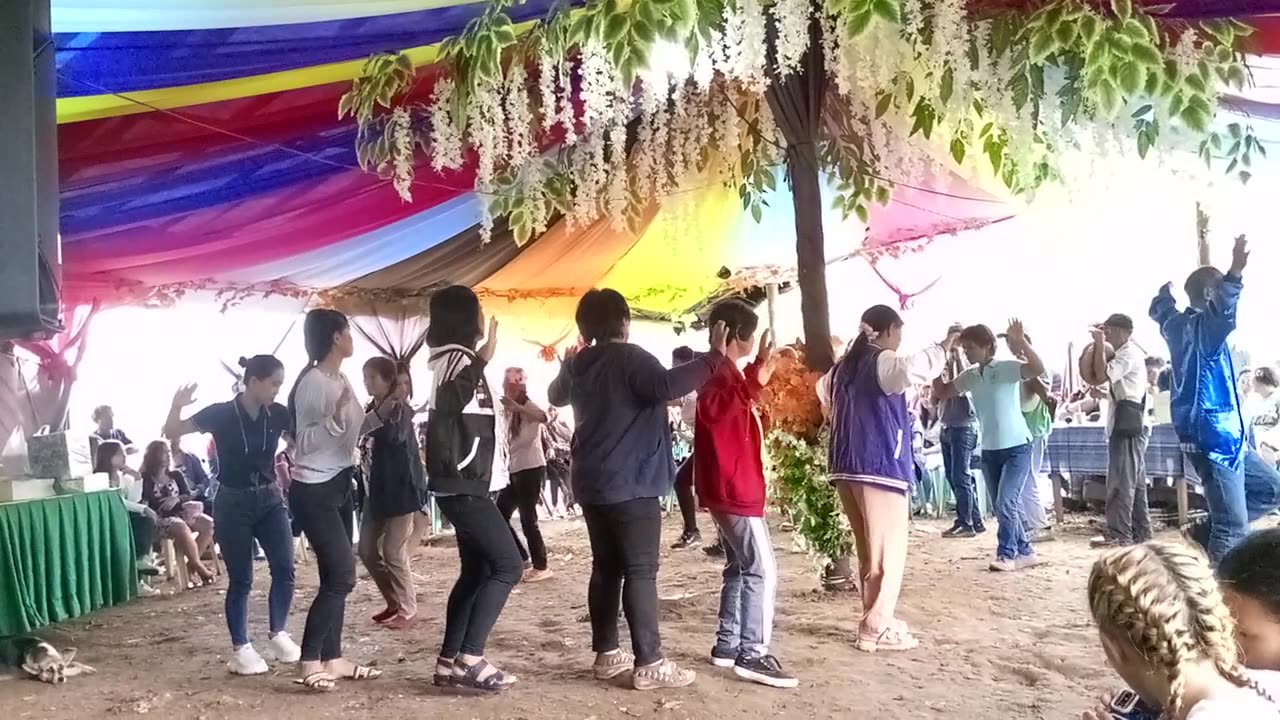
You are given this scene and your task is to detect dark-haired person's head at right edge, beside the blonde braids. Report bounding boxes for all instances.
[1217,528,1280,670]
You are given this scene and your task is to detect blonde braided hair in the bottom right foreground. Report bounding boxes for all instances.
[1088,542,1275,717]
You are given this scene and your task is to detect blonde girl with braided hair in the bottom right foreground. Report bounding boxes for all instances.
[1084,542,1280,720]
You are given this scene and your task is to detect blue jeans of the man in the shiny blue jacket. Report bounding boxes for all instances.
[1187,448,1280,565]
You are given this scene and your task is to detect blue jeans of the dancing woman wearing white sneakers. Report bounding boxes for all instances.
[214,483,293,647]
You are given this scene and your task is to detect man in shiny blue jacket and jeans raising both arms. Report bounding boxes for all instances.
[1151,234,1280,564]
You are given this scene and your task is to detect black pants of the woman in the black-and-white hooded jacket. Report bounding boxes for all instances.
[435,495,521,657]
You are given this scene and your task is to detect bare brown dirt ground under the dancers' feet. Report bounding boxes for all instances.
[0,516,1115,720]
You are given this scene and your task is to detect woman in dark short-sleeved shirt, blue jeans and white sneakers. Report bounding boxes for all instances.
[165,355,302,675]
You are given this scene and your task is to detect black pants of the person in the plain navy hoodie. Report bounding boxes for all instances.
[582,497,662,666]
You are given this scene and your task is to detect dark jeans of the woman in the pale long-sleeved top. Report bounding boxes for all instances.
[289,468,356,662]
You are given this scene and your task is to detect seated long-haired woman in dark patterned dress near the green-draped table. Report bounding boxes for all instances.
[140,439,214,585]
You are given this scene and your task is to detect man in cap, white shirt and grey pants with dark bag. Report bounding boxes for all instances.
[1092,313,1151,546]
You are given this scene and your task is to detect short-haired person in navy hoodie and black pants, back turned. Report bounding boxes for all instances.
[548,290,726,691]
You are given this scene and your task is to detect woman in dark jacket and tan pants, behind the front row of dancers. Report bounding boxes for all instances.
[360,357,426,630]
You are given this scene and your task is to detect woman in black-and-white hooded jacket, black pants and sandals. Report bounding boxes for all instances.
[426,286,522,691]
